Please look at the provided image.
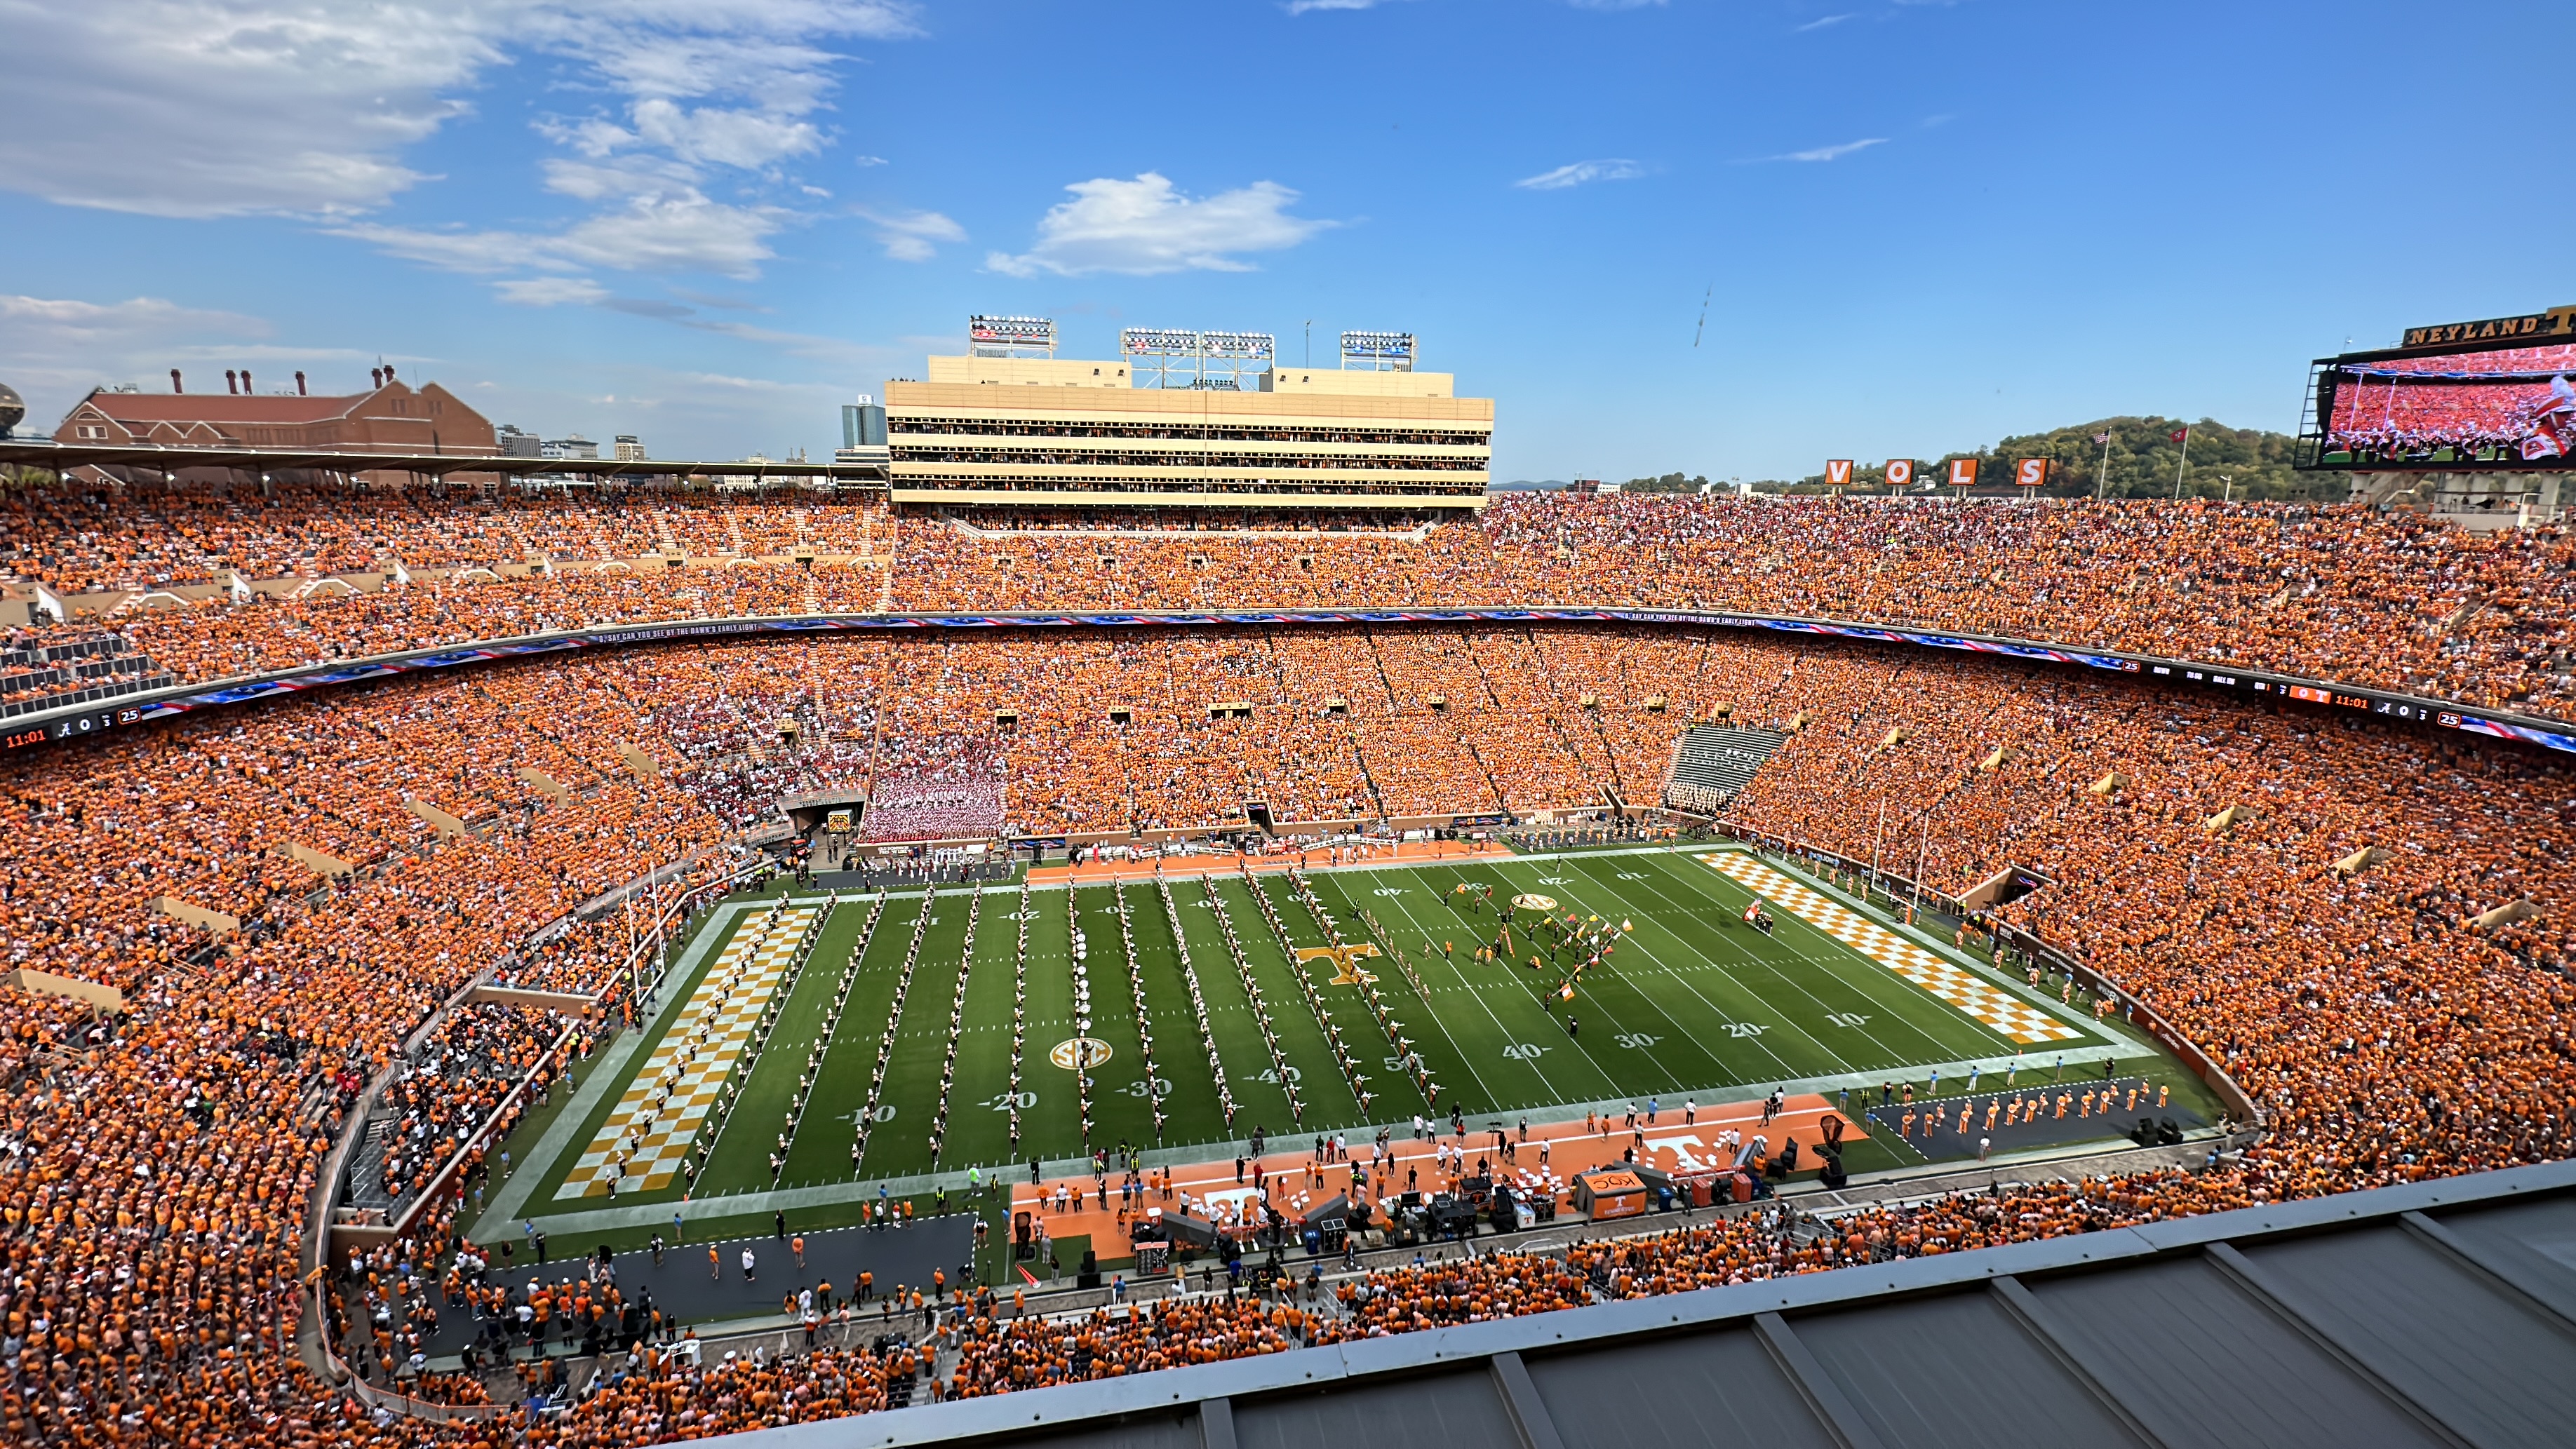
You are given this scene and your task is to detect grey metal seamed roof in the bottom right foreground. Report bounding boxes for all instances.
[695,1161,2576,1449]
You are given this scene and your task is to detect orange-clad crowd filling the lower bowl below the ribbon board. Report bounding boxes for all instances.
[0,617,2576,1444]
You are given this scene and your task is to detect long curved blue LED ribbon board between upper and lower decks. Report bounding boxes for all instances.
[0,605,2576,754]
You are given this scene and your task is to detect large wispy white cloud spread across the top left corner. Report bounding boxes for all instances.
[0,0,917,287]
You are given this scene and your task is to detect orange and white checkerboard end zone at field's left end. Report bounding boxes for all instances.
[554,906,821,1199]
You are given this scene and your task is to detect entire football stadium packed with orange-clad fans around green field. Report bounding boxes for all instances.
[0,289,2576,1449]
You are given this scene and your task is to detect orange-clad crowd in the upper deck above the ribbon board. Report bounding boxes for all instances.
[0,486,2576,731]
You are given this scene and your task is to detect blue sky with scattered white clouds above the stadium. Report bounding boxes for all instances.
[0,0,2576,479]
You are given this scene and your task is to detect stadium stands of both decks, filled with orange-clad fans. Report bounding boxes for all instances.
[0,555,2576,1444]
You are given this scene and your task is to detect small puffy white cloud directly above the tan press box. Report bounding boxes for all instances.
[984,173,1331,278]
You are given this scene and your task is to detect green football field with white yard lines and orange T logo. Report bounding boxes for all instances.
[497,849,2154,1230]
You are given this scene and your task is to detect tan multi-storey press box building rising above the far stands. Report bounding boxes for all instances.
[880,316,1494,515]
